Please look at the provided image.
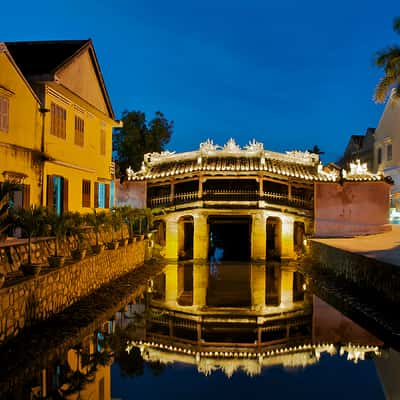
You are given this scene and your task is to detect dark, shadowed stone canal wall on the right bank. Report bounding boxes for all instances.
[311,241,400,304]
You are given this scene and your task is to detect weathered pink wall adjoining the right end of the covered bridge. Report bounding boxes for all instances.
[314,181,390,237]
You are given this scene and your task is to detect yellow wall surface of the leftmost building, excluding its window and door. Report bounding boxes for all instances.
[0,49,41,204]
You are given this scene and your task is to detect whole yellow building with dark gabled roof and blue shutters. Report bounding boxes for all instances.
[6,40,118,212]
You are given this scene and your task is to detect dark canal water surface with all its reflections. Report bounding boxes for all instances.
[0,262,400,400]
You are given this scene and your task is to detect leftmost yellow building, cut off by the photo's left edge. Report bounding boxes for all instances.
[0,43,41,207]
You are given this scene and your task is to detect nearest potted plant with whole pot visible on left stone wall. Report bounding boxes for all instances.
[12,205,48,275]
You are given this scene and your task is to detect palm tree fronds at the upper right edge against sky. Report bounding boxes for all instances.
[374,17,400,103]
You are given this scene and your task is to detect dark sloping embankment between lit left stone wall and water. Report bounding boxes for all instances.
[0,260,164,393]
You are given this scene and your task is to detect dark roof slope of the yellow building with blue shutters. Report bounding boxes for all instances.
[6,40,90,77]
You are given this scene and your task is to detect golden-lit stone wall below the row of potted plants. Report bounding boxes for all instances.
[0,241,147,344]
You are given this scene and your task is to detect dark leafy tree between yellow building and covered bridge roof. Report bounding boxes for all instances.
[113,111,174,175]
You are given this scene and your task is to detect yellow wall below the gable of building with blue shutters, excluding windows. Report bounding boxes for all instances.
[41,83,115,212]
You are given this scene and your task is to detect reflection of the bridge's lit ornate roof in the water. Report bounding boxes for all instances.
[126,341,380,377]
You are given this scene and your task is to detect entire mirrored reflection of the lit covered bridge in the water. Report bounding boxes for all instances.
[127,263,384,377]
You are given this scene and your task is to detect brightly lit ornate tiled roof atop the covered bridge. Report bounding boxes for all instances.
[127,139,380,182]
